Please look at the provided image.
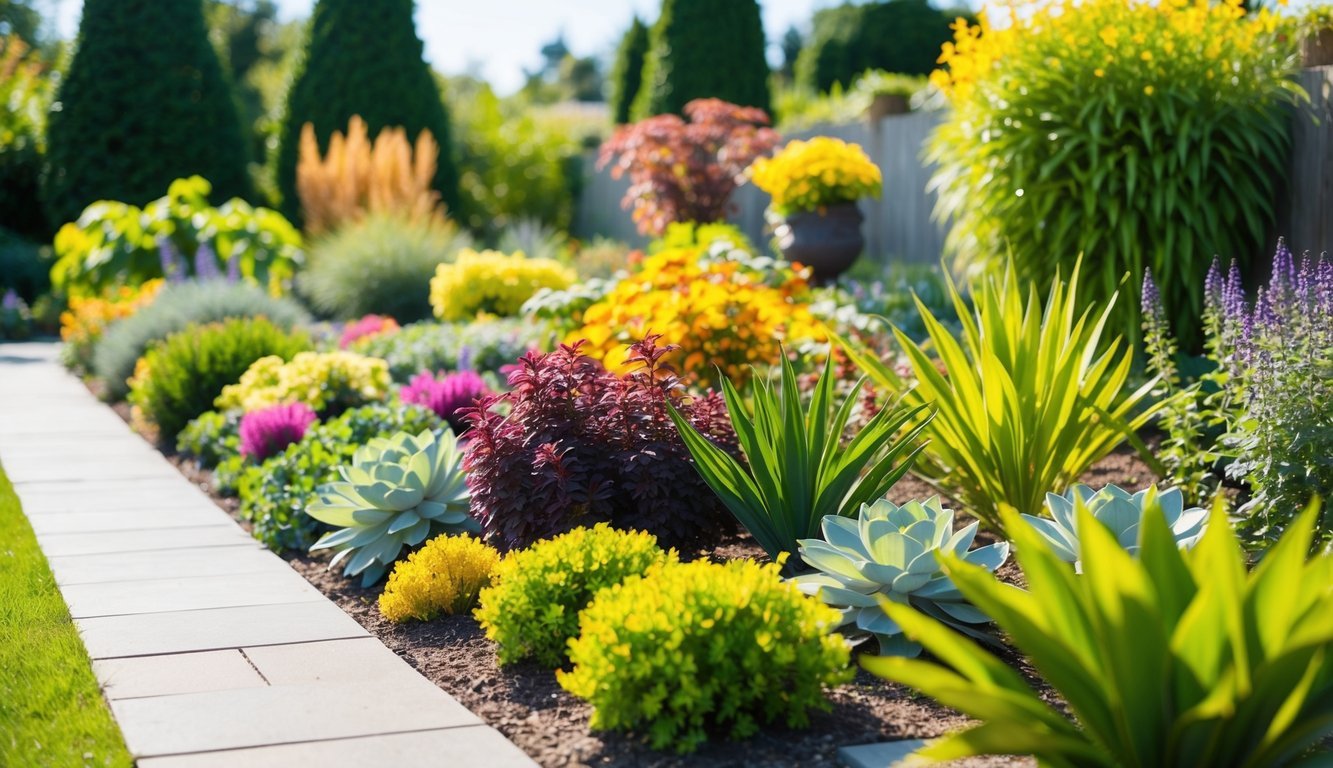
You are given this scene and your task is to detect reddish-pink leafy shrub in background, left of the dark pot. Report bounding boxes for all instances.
[597,99,778,236]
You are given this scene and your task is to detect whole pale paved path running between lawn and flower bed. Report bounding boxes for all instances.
[0,343,533,768]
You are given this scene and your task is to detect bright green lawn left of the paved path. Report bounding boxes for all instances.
[0,468,133,768]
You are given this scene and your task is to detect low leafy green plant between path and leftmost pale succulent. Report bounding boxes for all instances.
[233,403,440,551]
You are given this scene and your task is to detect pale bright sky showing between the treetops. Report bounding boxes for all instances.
[54,0,840,93]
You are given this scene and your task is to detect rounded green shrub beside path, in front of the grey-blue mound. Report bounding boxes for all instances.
[129,317,311,444]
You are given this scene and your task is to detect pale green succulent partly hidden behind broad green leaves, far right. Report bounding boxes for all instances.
[1022,485,1208,572]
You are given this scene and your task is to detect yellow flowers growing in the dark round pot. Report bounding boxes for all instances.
[748,136,884,216]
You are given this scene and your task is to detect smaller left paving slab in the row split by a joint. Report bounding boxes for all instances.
[92,649,268,699]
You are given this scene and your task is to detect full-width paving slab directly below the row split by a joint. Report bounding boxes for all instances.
[111,683,481,760]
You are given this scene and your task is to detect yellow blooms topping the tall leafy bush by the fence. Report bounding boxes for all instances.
[930,0,1278,104]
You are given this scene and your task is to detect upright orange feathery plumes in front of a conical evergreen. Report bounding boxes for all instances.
[296,115,444,235]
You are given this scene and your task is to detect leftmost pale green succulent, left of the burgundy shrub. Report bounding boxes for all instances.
[305,429,481,587]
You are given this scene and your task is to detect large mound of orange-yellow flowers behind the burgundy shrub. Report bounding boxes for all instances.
[567,248,824,387]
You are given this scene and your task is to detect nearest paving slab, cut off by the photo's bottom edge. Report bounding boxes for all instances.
[139,725,536,768]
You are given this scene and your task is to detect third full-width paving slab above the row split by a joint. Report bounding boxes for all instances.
[47,539,273,589]
